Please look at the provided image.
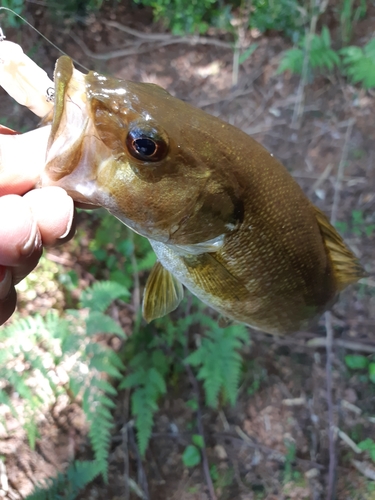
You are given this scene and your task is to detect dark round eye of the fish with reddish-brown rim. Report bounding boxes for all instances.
[126,127,168,162]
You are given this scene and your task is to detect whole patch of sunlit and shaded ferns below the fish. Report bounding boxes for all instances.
[0,214,249,500]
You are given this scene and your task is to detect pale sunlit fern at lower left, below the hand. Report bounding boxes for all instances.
[0,282,129,478]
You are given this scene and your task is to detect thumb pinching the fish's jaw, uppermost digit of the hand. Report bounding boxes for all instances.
[0,126,51,196]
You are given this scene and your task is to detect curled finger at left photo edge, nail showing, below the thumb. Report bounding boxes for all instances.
[0,195,42,266]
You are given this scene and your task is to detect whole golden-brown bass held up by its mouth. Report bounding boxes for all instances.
[42,56,364,334]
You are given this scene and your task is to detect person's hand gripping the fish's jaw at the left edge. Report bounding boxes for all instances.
[0,126,74,325]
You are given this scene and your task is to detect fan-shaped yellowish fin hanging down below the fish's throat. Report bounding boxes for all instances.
[142,262,184,323]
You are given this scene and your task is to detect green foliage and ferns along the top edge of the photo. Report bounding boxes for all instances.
[3,0,375,89]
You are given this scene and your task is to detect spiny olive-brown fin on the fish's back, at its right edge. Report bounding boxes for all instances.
[314,206,367,291]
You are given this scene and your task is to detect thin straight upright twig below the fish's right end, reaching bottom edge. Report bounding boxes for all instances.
[325,311,336,500]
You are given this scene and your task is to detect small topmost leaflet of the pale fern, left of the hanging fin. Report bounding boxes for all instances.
[81,281,130,312]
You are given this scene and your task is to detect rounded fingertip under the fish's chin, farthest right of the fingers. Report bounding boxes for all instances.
[24,186,74,246]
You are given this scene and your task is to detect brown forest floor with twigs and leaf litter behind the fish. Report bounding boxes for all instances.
[0,1,375,500]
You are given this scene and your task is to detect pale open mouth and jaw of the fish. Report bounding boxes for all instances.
[41,56,108,206]
